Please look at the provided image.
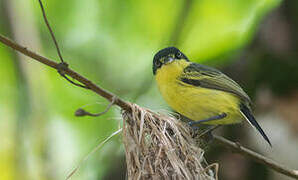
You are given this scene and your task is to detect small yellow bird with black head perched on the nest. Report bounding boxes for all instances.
[152,47,272,146]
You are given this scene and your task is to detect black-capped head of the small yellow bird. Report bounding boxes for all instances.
[153,47,188,75]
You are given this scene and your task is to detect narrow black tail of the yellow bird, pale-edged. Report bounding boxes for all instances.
[240,104,272,147]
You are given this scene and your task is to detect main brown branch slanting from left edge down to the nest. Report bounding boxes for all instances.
[0,34,131,111]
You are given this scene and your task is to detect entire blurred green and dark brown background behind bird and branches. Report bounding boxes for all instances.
[0,0,298,180]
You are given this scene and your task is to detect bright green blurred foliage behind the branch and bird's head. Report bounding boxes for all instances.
[0,0,280,179]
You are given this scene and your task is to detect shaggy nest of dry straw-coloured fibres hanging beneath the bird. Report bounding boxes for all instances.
[122,104,217,180]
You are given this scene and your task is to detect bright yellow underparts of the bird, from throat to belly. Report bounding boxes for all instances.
[156,60,242,124]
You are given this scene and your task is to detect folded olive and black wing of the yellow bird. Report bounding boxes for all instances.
[180,63,251,104]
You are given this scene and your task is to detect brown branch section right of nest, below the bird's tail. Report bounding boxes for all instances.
[214,135,298,179]
